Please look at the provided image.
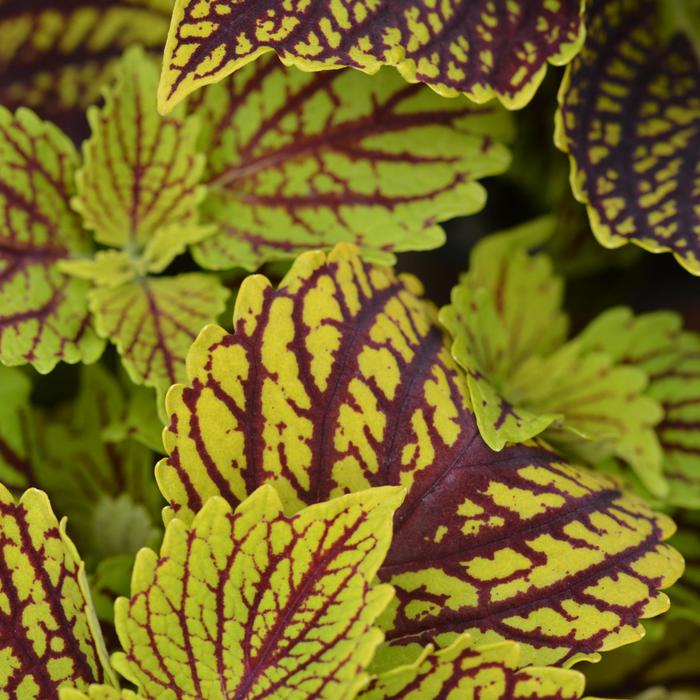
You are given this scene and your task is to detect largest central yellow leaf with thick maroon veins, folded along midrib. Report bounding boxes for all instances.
[156,246,682,668]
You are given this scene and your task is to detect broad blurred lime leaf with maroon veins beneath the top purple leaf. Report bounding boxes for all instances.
[190,57,511,269]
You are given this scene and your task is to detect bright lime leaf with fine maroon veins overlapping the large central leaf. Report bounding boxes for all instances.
[113,486,402,698]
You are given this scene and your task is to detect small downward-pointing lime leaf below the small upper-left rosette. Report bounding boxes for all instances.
[90,272,228,390]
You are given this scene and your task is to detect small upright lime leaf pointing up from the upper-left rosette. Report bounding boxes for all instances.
[73,48,211,262]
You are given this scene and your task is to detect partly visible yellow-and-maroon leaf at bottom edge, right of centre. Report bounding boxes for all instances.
[358,635,584,700]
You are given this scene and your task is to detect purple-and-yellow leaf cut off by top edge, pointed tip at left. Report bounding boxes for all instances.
[158,0,583,111]
